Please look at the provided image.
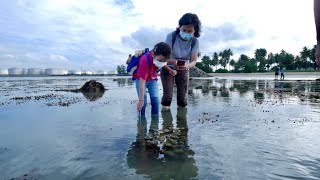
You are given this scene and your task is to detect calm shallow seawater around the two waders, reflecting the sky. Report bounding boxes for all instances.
[0,77,320,180]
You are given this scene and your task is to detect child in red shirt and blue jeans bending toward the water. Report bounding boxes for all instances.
[135,42,171,116]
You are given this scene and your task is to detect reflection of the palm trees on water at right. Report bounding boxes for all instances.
[188,79,320,101]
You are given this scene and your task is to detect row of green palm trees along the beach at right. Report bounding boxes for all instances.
[196,45,317,73]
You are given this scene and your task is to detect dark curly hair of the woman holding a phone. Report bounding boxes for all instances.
[176,13,201,37]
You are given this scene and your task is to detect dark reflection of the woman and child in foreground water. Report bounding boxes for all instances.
[127,108,198,179]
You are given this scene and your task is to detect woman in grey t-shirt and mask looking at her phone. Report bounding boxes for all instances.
[160,13,201,110]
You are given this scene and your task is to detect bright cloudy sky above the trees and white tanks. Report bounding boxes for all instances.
[0,0,316,70]
